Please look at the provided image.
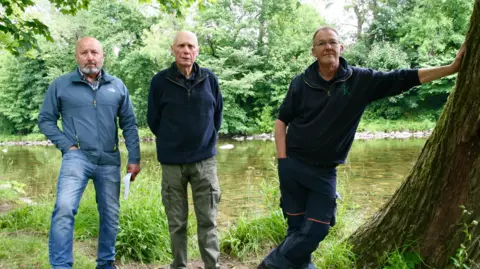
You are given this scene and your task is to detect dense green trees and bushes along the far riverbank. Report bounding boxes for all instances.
[0,0,473,134]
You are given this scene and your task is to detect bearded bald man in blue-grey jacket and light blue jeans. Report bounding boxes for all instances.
[38,37,140,269]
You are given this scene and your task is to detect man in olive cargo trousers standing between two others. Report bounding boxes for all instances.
[147,31,223,269]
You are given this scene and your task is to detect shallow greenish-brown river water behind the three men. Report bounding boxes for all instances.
[0,139,425,222]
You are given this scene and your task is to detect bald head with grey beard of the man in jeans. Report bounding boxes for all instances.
[75,36,104,76]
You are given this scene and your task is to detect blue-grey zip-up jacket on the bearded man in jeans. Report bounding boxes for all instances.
[38,70,140,165]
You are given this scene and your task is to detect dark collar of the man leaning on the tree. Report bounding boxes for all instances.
[302,57,352,89]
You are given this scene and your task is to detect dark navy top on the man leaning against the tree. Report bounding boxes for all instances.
[278,58,420,165]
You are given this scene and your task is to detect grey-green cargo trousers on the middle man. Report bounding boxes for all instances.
[162,157,221,269]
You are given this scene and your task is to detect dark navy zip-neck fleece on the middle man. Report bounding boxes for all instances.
[147,63,223,164]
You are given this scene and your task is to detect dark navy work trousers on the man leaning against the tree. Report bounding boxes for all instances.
[264,158,337,269]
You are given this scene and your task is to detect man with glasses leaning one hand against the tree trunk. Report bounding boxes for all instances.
[258,27,464,269]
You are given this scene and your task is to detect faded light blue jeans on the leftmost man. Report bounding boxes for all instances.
[48,150,120,269]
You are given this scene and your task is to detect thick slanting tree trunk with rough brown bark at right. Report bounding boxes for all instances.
[349,0,480,268]
